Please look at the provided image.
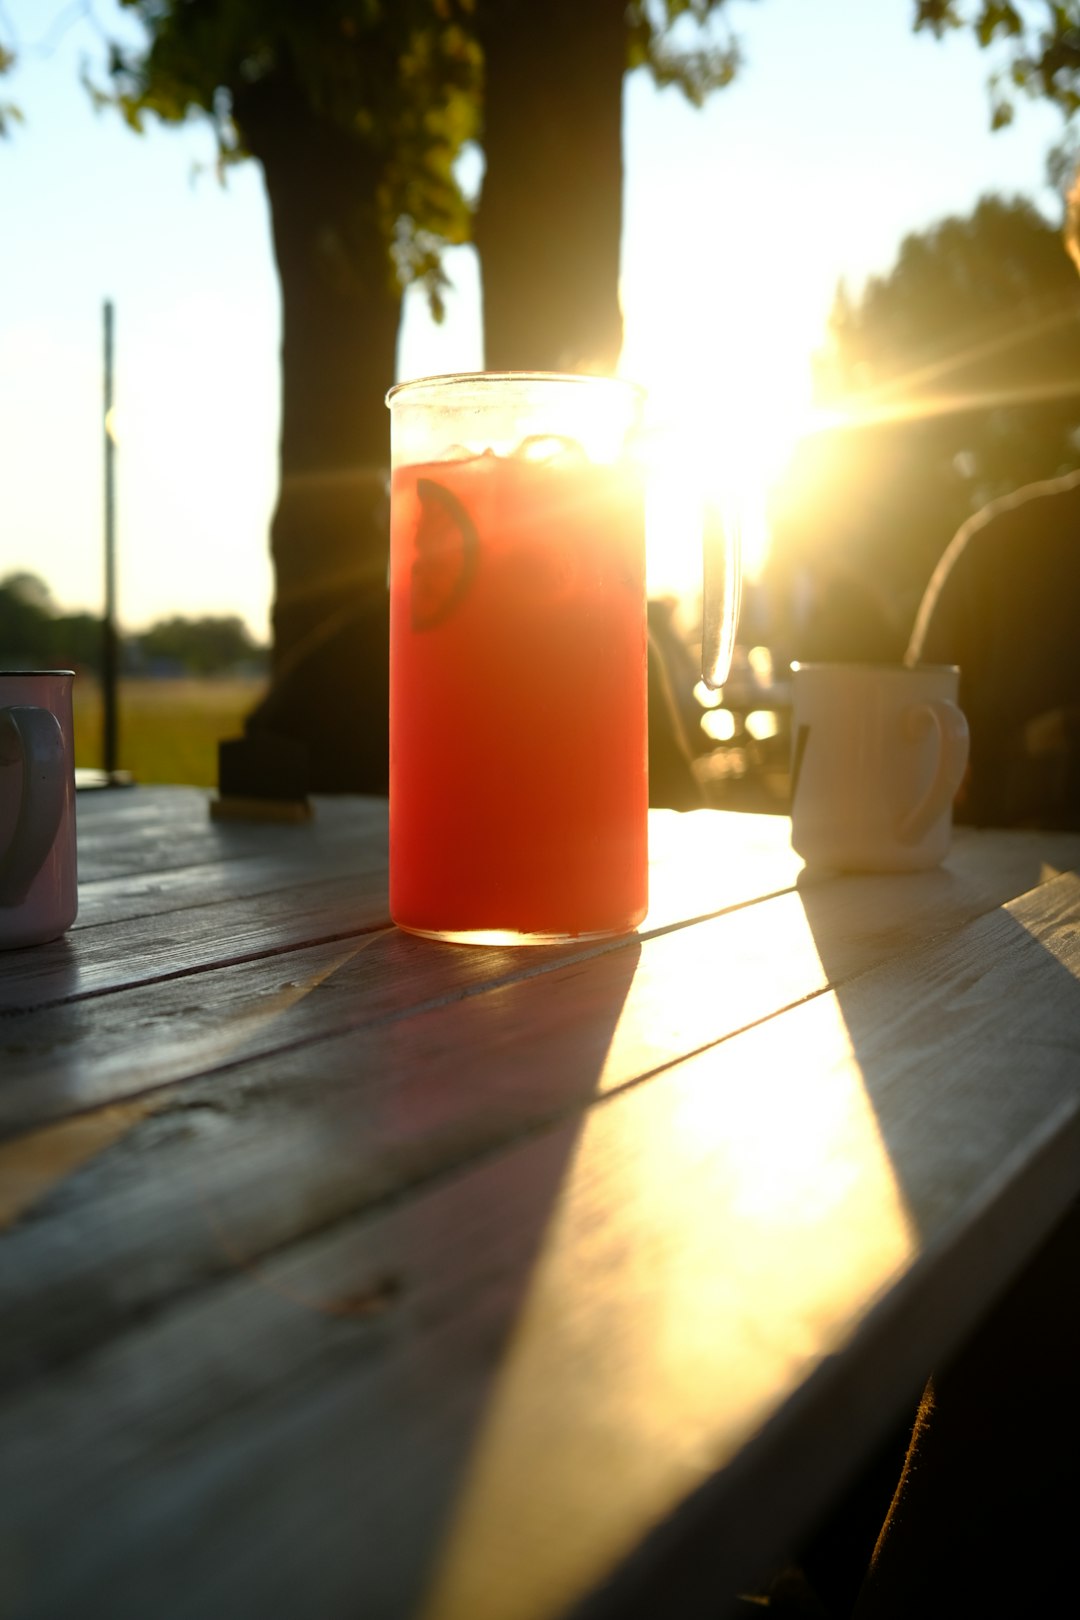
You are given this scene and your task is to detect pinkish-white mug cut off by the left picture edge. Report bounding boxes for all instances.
[0,669,78,948]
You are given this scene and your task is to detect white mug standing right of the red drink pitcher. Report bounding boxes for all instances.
[792,664,968,872]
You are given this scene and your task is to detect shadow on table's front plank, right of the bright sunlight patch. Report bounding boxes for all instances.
[798,834,1080,1268]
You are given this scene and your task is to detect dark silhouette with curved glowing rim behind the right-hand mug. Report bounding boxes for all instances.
[907,473,1080,828]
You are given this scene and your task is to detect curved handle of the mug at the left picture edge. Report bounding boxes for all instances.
[0,706,66,906]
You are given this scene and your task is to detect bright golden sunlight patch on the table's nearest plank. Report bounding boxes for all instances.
[421,952,913,1620]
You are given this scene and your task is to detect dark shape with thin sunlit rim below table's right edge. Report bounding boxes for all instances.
[855,1204,1080,1620]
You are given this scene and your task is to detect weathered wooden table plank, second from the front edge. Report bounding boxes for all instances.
[0,878,1072,1406]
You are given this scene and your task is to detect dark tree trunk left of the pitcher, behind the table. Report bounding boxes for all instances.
[235,70,402,794]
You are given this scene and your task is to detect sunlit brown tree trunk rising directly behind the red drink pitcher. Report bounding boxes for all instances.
[476,0,627,371]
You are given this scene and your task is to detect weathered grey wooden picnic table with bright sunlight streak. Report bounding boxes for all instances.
[0,787,1080,1620]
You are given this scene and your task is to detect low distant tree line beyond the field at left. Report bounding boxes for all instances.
[0,572,267,676]
